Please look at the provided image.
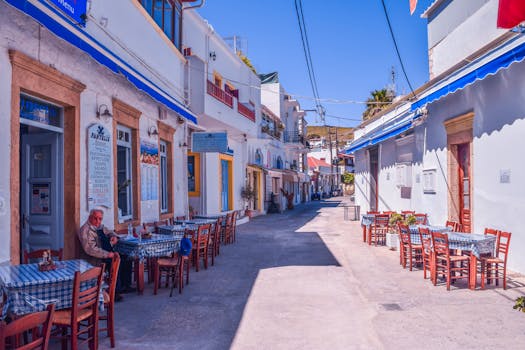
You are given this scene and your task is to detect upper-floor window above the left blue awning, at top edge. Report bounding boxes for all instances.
[140,0,182,49]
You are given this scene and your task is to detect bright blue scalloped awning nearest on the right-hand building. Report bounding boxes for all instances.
[410,39,525,111]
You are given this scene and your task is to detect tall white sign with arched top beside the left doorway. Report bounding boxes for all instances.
[88,124,113,210]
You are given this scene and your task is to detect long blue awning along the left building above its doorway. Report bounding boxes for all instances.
[5,0,197,123]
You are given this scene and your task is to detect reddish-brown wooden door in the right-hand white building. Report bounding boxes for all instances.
[458,143,472,232]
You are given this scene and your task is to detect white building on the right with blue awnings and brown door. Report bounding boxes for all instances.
[347,0,525,273]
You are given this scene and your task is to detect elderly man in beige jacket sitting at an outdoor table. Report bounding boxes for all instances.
[78,209,134,301]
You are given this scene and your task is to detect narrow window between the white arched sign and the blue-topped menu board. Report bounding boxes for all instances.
[117,125,133,222]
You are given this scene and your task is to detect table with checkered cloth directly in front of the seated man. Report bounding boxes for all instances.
[113,234,183,294]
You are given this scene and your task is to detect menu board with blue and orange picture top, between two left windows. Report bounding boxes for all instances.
[140,139,159,201]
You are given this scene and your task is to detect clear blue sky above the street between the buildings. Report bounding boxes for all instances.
[199,0,432,126]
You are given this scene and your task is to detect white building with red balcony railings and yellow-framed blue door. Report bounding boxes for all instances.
[183,12,263,214]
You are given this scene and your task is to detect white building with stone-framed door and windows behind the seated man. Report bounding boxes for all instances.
[0,0,197,263]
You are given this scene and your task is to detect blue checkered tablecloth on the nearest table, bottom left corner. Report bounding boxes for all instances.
[0,260,96,318]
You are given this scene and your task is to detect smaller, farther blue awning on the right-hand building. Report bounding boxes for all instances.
[345,113,415,154]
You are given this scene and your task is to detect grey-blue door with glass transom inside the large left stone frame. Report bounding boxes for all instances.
[20,96,64,259]
